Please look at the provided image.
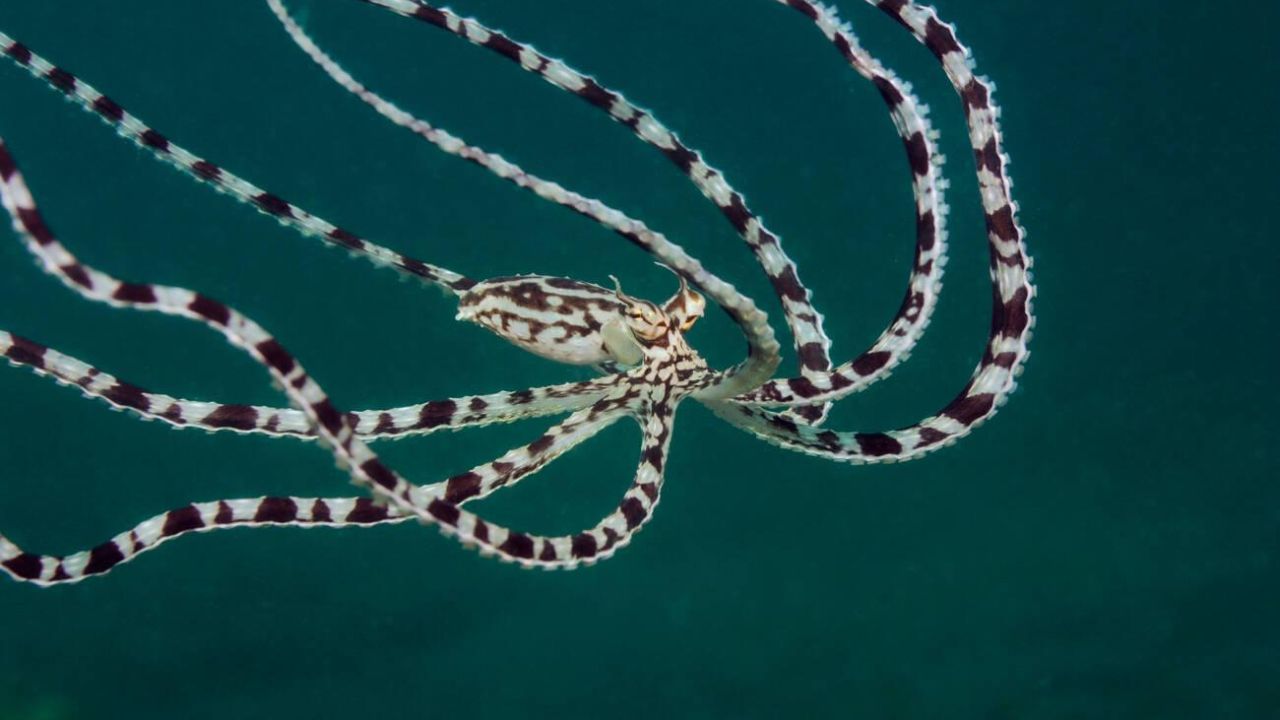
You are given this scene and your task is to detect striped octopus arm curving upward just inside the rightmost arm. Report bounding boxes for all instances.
[735,0,948,405]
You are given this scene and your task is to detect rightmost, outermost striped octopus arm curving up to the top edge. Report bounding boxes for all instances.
[713,0,1036,462]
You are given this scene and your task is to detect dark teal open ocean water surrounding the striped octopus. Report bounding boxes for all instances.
[0,0,1280,720]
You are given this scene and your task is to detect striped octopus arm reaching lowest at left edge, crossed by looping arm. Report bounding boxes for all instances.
[0,389,622,579]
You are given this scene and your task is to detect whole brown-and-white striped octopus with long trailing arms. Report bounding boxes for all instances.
[0,0,1034,585]
